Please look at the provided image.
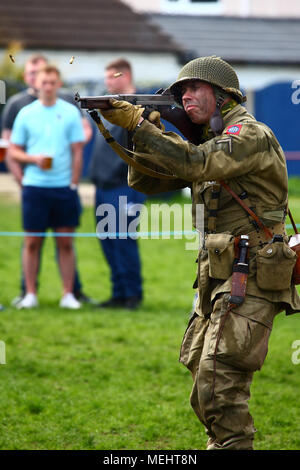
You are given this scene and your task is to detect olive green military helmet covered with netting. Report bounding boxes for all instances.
[169,56,247,104]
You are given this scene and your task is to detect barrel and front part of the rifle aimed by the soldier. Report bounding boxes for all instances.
[75,93,175,109]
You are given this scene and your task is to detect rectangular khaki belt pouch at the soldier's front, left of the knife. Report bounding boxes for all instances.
[205,233,234,280]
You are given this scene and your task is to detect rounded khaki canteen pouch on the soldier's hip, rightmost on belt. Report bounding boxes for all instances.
[256,239,297,291]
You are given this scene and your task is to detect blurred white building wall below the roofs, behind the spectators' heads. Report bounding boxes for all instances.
[0,50,300,96]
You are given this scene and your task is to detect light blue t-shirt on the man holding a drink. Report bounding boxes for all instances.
[11,98,84,188]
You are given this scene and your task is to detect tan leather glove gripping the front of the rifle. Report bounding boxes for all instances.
[99,99,144,131]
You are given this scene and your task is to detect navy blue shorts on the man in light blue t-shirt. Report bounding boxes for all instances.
[22,186,81,232]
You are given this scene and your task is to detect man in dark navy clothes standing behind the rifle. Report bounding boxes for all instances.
[90,59,145,309]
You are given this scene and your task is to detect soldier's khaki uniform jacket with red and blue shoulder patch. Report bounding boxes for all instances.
[128,105,300,314]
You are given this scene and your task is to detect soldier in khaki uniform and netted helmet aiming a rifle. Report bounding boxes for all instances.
[95,56,300,450]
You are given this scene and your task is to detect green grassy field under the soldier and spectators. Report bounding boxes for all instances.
[0,189,300,450]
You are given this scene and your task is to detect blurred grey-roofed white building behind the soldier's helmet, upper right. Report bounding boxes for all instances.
[122,0,300,102]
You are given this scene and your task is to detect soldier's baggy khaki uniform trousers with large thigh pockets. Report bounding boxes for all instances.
[180,294,281,450]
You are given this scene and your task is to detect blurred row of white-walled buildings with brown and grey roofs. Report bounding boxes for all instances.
[0,0,300,97]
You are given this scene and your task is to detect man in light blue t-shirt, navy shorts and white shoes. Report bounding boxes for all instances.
[10,65,84,308]
